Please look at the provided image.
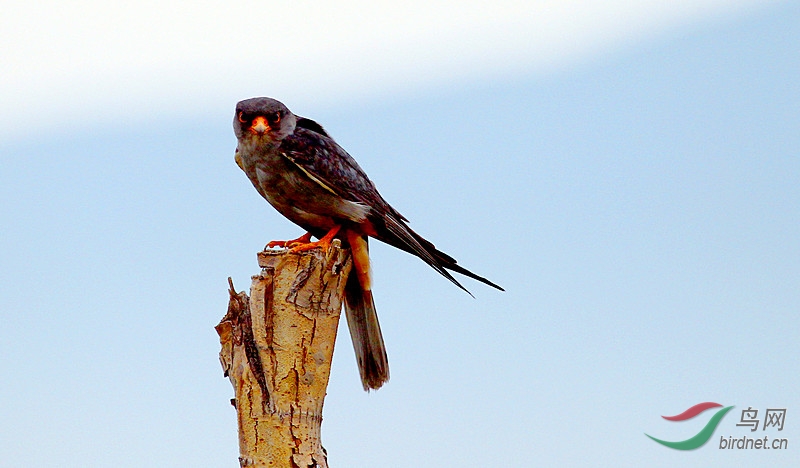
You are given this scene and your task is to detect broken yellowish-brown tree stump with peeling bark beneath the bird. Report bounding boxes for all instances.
[216,243,351,468]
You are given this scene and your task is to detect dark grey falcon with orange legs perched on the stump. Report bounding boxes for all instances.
[233,97,503,391]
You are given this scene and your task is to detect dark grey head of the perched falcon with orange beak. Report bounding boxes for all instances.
[233,97,297,143]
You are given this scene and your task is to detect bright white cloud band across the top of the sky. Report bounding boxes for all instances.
[0,0,776,138]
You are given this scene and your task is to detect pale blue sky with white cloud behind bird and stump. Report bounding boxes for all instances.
[0,2,800,467]
